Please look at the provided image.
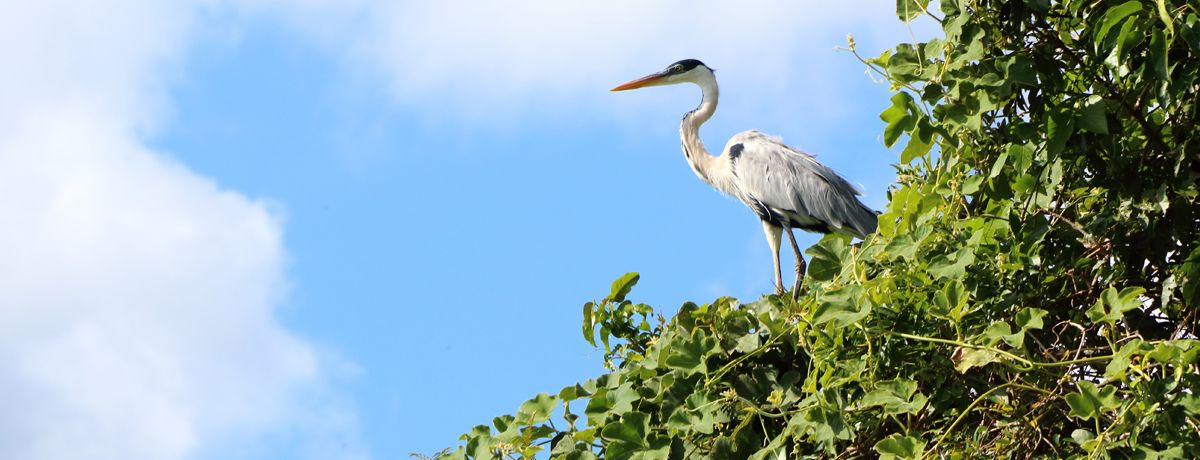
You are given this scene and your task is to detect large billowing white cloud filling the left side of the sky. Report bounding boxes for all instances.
[0,0,361,459]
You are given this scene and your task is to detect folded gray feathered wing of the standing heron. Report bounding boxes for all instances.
[724,131,877,238]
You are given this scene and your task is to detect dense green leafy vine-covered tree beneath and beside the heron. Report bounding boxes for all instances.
[432,0,1200,459]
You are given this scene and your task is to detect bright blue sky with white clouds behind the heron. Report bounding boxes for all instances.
[0,0,929,459]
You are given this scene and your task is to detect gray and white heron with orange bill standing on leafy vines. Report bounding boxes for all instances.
[612,59,878,298]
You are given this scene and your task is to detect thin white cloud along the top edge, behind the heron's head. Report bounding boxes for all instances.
[300,0,926,121]
